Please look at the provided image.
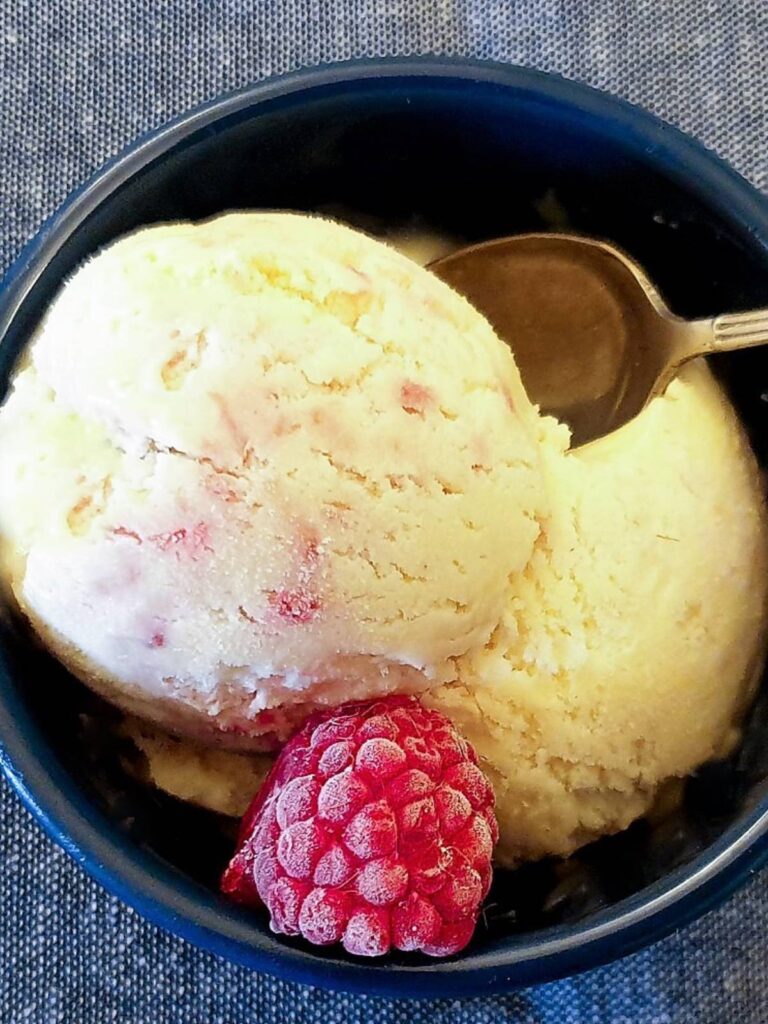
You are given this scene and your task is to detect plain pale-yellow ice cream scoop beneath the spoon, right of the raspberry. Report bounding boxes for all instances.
[426,364,768,864]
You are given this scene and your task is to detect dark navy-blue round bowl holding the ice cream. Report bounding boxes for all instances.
[0,60,768,996]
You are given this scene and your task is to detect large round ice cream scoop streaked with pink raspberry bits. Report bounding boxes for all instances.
[0,214,562,745]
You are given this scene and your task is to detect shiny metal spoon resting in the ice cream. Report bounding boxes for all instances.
[429,234,768,447]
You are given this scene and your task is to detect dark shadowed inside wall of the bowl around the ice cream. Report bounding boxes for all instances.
[0,68,768,987]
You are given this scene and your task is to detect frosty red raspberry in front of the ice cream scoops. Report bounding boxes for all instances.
[221,696,499,956]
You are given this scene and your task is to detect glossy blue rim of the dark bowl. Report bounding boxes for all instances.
[0,56,768,998]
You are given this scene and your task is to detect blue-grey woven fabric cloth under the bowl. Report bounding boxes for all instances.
[0,0,768,1024]
